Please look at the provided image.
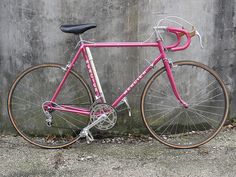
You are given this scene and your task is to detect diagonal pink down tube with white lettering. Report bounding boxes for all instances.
[112,55,162,108]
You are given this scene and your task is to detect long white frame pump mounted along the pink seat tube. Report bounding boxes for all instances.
[85,47,106,103]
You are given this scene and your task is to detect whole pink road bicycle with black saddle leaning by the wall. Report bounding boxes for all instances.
[8,18,229,148]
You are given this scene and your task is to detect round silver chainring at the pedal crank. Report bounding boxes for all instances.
[90,103,117,130]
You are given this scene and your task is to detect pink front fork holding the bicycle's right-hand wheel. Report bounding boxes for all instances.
[163,57,189,108]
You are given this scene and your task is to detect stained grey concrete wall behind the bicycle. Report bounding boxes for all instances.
[0,0,236,131]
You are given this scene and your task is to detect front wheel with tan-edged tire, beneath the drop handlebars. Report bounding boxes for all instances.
[141,61,229,148]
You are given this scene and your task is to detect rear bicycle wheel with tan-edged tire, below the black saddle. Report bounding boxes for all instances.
[7,63,93,148]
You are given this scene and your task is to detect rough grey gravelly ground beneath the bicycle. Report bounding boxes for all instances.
[0,127,236,177]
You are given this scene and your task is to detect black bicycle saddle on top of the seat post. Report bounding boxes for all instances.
[60,23,97,34]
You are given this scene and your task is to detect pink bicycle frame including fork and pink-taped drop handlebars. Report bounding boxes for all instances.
[48,27,191,116]
